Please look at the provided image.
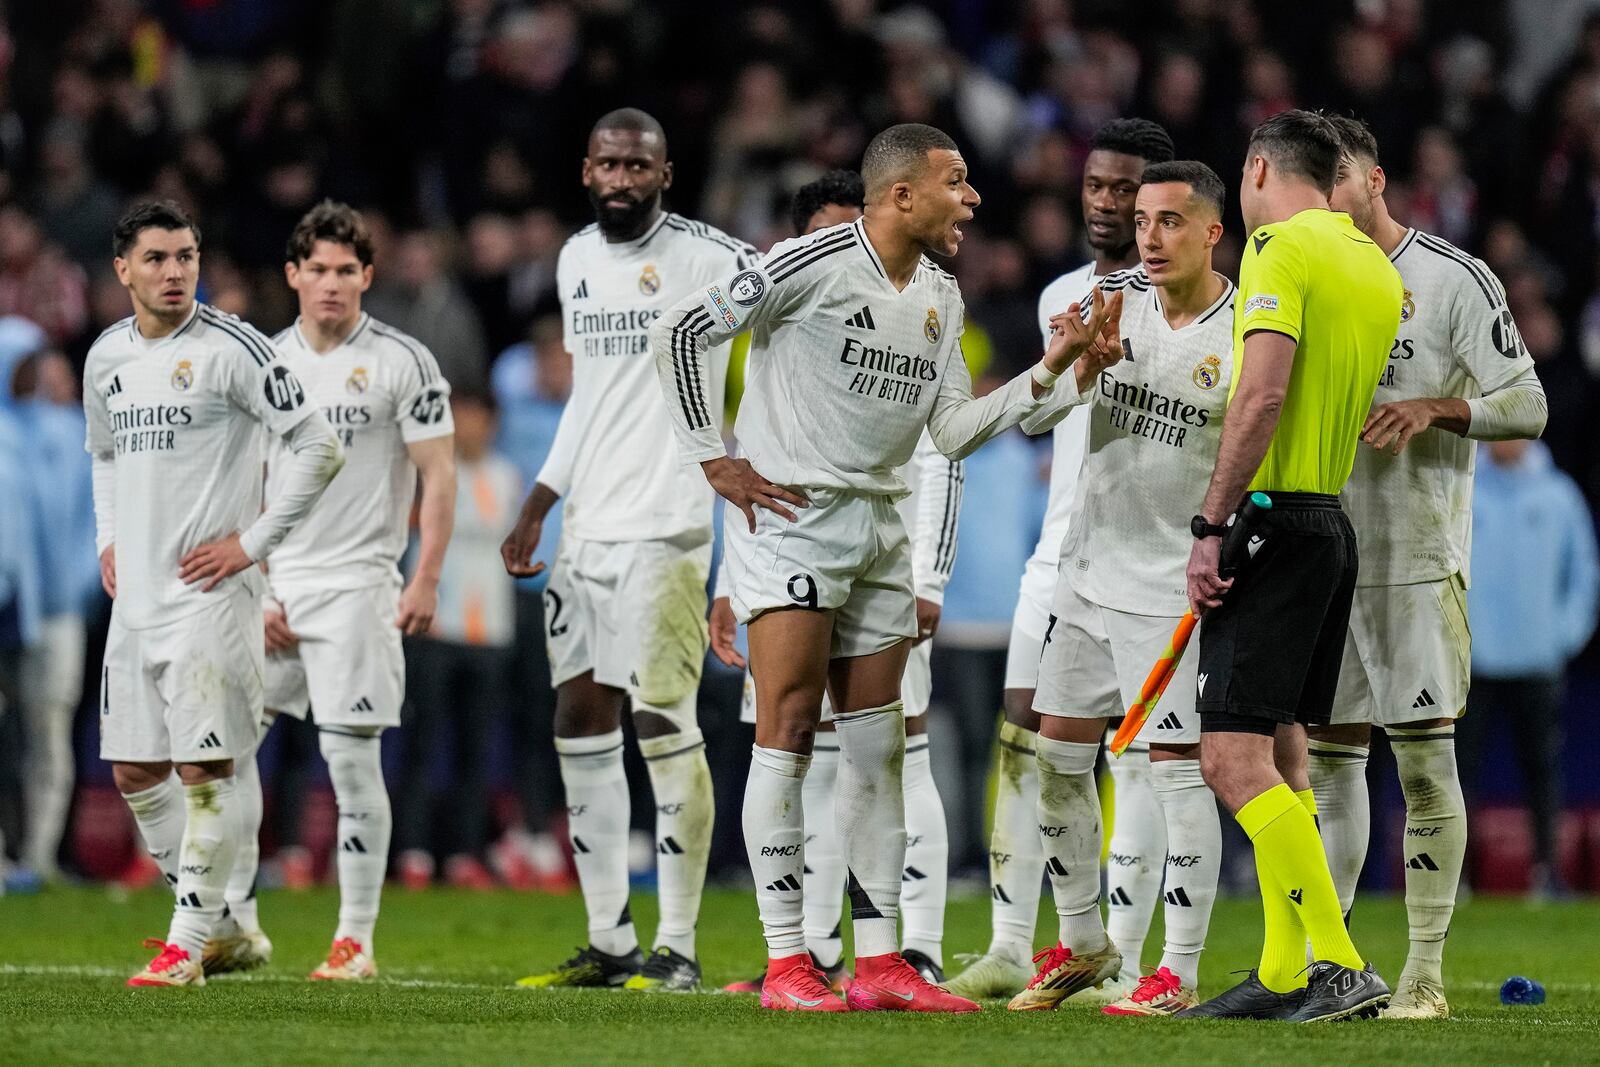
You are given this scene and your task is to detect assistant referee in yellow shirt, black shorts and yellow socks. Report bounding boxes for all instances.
[1182,110,1403,1022]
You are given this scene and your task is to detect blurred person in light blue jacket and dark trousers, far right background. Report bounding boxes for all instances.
[1458,442,1600,893]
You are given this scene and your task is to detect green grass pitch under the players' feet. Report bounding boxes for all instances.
[0,888,1600,1067]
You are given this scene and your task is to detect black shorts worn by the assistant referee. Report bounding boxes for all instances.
[1195,493,1357,734]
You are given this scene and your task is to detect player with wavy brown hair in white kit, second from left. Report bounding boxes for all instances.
[206,202,456,981]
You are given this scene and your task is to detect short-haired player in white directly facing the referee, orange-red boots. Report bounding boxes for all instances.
[1011,162,1234,1016]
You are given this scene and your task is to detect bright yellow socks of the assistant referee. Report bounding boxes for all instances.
[1237,784,1363,993]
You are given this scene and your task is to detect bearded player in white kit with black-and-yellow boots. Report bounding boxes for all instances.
[502,109,755,990]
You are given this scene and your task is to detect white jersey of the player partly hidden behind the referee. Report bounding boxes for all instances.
[1342,230,1533,585]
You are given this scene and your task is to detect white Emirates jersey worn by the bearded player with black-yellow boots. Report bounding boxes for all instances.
[538,211,755,541]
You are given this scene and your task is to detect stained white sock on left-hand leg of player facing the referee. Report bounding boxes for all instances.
[1038,736,1106,955]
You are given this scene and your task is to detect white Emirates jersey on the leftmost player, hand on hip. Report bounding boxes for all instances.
[83,302,317,630]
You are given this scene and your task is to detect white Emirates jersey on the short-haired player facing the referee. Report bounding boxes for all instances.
[1061,267,1234,616]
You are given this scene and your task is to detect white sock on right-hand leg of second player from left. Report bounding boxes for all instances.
[317,729,394,958]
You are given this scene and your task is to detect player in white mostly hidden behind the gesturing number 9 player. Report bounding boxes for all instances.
[710,171,965,993]
